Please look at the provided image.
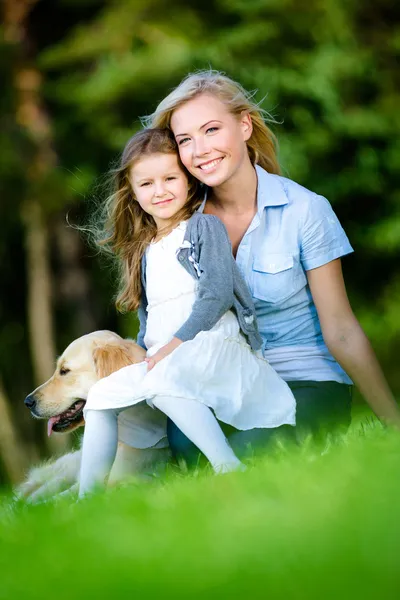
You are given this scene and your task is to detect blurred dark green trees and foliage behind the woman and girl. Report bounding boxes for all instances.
[0,0,400,482]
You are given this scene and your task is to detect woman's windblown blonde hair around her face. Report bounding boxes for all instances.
[143,70,280,174]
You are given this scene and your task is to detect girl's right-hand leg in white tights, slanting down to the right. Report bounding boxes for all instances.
[152,396,242,473]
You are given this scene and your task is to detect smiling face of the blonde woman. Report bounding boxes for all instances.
[171,94,253,187]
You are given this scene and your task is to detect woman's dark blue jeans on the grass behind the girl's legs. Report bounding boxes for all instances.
[167,381,352,467]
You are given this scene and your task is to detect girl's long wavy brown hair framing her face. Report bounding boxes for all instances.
[94,128,202,312]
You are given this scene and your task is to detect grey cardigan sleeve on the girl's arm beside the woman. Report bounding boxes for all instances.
[175,215,234,342]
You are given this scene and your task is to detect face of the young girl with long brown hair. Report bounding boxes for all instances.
[129,153,188,229]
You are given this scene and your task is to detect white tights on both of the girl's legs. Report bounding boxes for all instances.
[79,396,242,496]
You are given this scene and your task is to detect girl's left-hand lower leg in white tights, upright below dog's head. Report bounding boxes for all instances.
[79,409,120,497]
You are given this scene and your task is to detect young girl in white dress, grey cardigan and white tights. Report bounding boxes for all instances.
[80,129,295,495]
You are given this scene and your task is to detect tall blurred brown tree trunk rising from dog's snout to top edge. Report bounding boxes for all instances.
[3,0,70,452]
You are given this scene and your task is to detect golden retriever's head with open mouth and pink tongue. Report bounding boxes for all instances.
[25,331,146,435]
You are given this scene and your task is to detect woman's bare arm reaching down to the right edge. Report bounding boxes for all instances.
[307,259,400,427]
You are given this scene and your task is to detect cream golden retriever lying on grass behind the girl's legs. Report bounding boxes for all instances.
[17,331,170,502]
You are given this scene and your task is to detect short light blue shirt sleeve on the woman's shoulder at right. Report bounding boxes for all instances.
[300,194,353,271]
